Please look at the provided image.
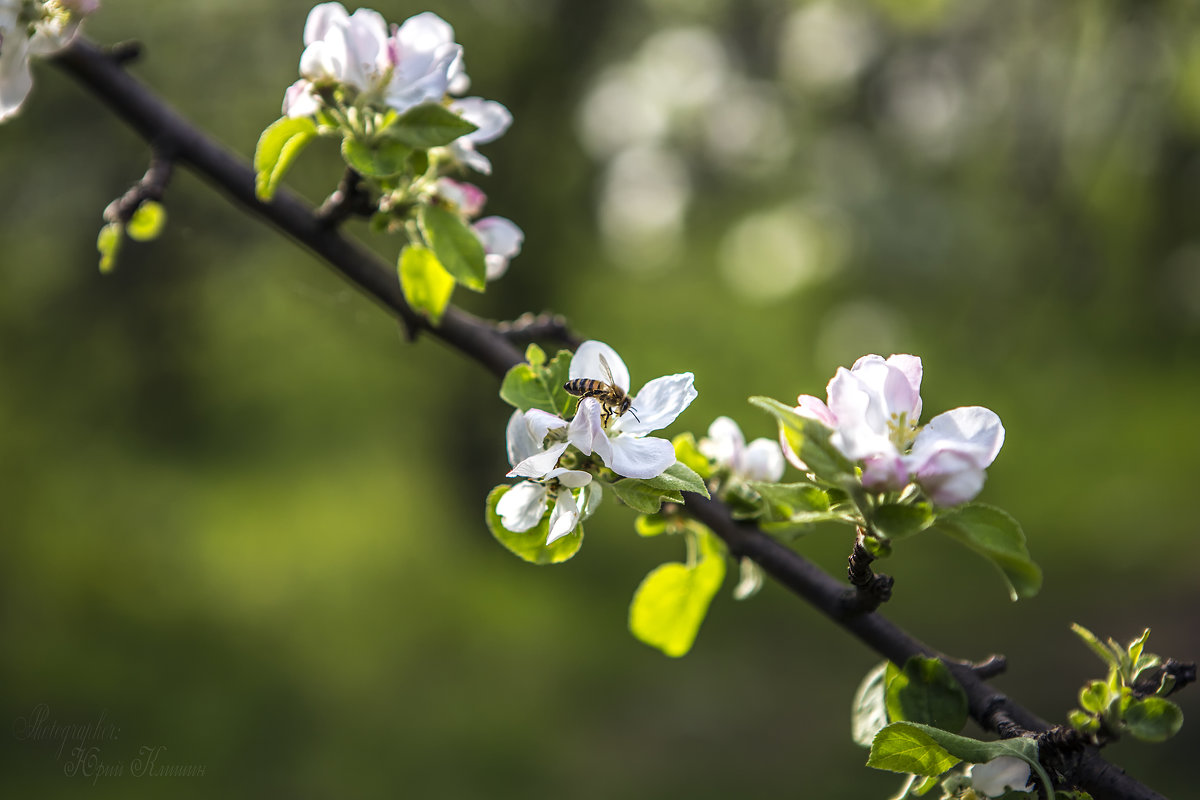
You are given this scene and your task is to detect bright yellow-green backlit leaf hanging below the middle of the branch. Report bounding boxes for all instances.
[629,531,725,658]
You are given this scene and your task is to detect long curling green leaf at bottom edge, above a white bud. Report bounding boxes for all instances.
[866,722,1055,800]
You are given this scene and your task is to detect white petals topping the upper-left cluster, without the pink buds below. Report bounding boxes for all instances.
[283,2,512,174]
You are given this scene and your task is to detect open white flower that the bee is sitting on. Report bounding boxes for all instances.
[568,341,696,479]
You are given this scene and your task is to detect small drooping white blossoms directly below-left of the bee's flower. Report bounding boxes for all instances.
[496,409,600,545]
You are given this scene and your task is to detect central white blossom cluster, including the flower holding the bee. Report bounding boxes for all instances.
[496,341,696,545]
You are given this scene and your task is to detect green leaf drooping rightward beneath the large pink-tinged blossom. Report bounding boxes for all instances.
[934,503,1042,600]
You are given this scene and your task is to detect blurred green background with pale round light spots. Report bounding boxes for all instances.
[0,0,1200,798]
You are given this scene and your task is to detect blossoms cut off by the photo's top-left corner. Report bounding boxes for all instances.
[0,0,100,122]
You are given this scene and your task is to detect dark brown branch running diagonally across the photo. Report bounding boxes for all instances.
[54,37,1176,800]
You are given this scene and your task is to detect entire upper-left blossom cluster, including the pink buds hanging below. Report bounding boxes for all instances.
[283,2,524,279]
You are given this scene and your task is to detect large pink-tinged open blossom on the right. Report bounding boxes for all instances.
[780,355,1004,506]
